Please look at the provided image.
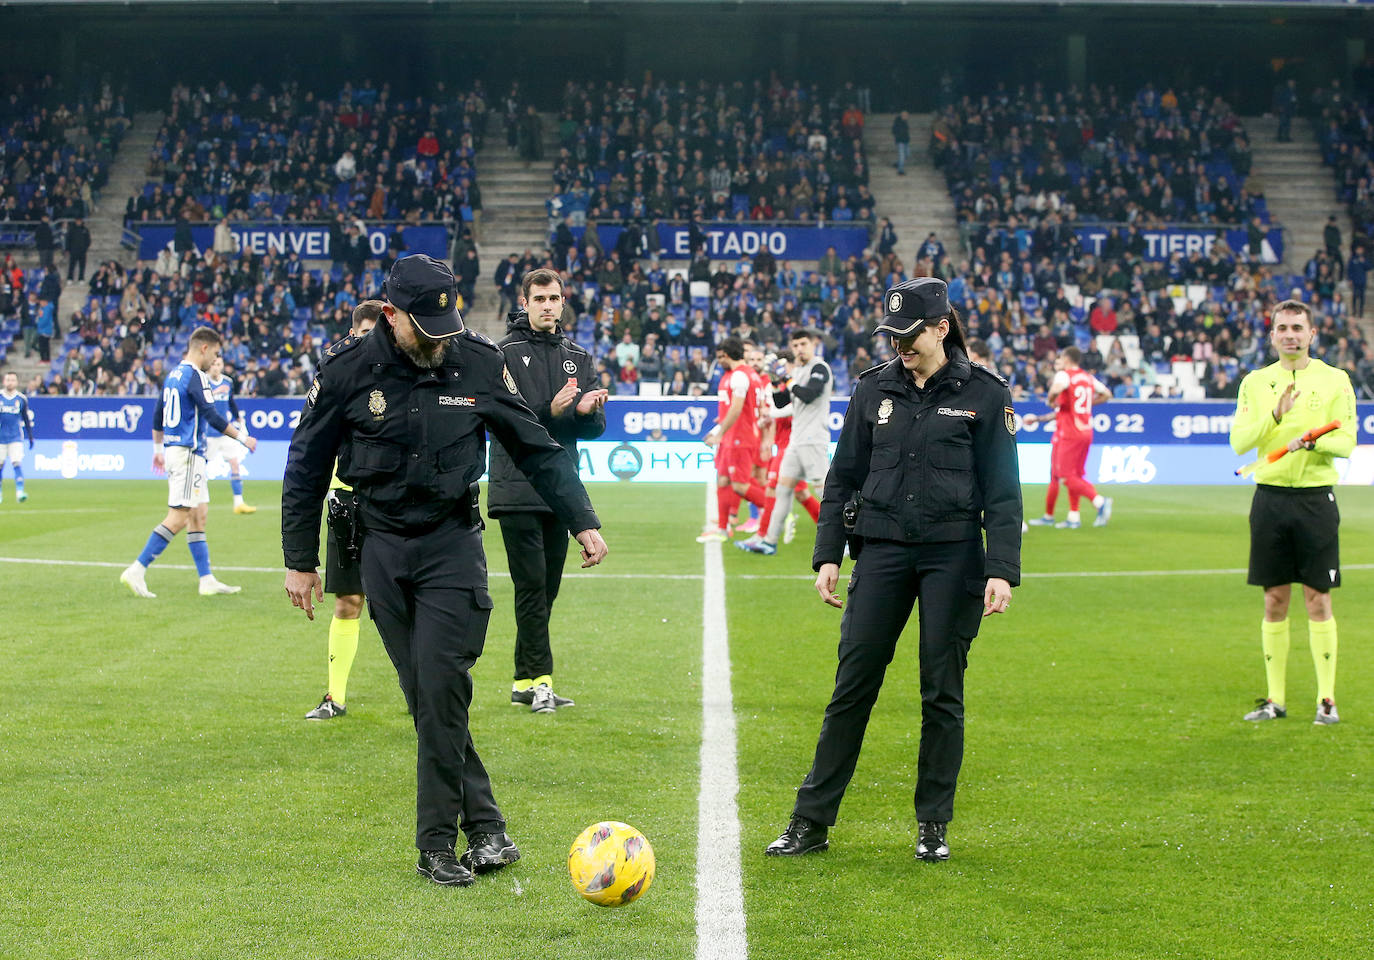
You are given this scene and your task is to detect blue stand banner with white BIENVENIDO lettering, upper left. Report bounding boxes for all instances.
[132,221,451,260]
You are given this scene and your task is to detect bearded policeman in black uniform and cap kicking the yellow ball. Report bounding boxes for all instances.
[282,254,606,886]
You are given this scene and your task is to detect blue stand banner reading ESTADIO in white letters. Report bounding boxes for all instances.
[572,222,868,260]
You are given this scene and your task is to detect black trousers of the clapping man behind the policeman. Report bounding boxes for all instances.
[499,512,567,680]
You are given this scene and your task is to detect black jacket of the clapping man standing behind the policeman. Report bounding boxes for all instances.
[486,310,606,518]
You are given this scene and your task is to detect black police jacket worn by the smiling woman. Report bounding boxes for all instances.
[811,349,1021,586]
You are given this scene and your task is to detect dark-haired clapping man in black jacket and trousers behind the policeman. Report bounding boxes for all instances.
[486,269,606,713]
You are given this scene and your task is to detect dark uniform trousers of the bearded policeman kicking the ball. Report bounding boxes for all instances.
[363,518,506,850]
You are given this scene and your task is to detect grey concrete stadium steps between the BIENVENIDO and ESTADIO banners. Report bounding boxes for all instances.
[469,113,559,339]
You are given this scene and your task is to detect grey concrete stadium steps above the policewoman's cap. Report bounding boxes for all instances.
[863,113,967,273]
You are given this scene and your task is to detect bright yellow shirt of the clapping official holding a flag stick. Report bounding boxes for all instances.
[1231,358,1359,486]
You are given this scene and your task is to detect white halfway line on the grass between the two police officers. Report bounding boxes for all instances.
[697,485,749,960]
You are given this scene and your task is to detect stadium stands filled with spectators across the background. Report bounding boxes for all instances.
[0,81,1374,398]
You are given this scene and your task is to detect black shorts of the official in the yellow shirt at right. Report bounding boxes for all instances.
[1248,483,1341,592]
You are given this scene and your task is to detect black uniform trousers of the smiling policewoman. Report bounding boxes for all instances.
[793,540,987,825]
